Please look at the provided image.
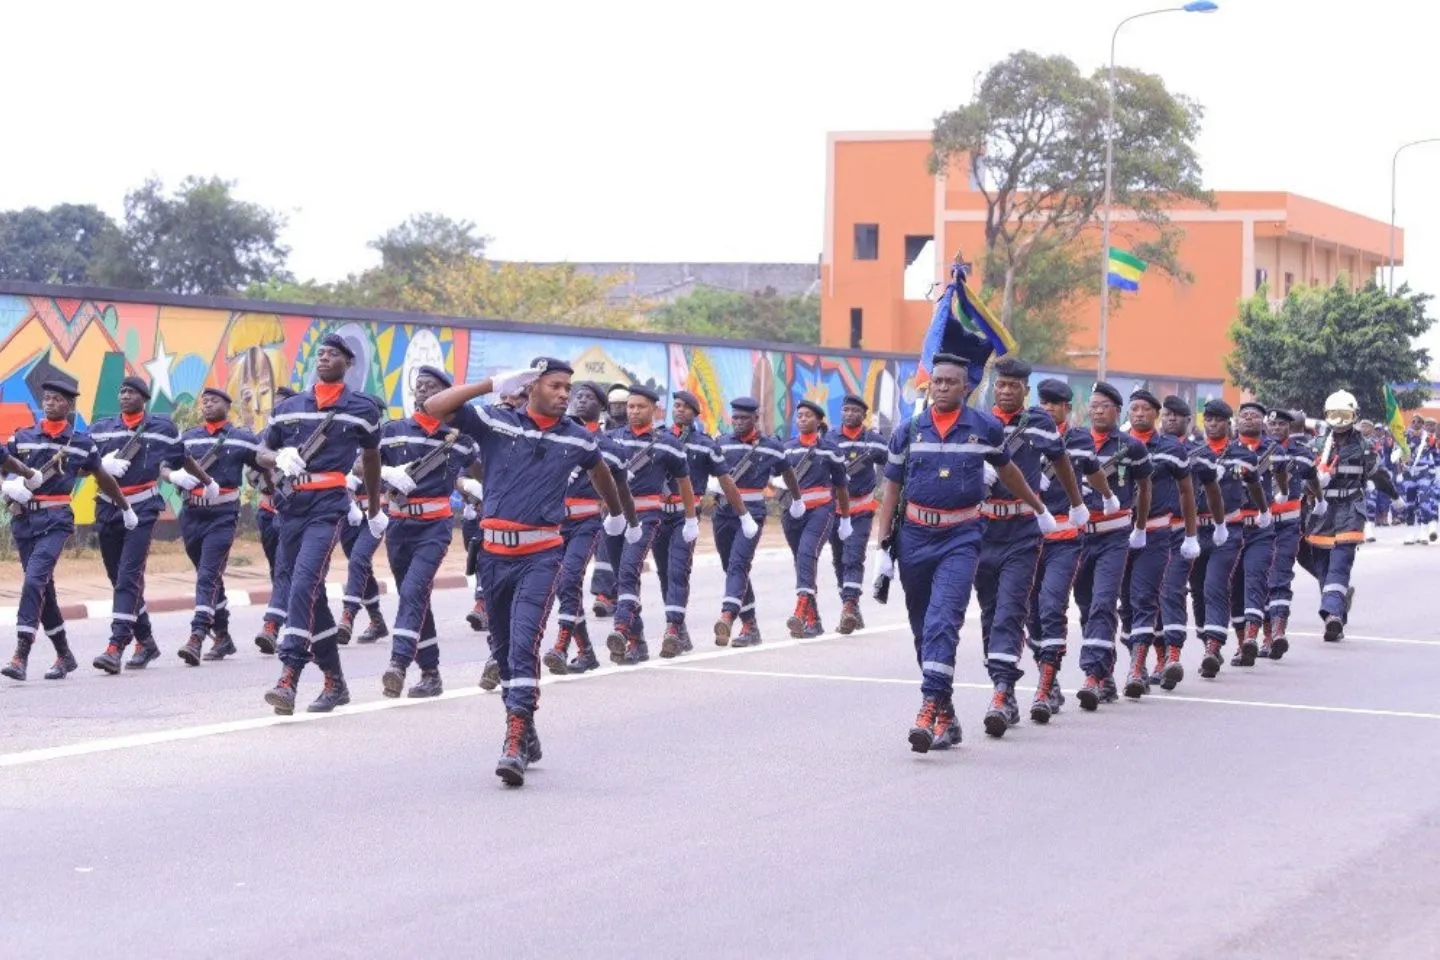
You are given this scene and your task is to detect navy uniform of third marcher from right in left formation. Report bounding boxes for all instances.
[713,430,785,627]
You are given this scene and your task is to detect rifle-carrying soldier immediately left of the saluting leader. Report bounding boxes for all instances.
[380,366,477,697]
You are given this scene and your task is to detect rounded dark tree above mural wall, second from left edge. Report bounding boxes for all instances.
[104,177,289,295]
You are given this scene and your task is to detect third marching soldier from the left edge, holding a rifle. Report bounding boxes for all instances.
[160,387,261,666]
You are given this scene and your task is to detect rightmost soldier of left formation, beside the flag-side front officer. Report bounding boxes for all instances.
[829,394,890,633]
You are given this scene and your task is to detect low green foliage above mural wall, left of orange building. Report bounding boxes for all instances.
[647,286,819,344]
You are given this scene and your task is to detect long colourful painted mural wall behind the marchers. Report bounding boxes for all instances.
[0,294,1221,524]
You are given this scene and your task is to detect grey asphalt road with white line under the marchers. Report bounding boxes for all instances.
[0,531,1440,960]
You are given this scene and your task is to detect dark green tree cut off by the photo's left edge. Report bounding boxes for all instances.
[0,203,120,284]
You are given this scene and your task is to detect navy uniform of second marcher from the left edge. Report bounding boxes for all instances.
[91,413,184,656]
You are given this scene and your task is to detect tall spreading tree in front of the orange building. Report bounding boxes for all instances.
[929,50,1212,360]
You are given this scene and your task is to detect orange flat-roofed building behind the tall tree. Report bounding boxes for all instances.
[821,132,1404,393]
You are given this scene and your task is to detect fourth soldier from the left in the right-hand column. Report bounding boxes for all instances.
[1074,380,1153,711]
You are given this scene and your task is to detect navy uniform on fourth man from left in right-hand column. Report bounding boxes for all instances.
[1074,432,1152,679]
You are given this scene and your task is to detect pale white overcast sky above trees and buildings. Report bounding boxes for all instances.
[0,0,1440,359]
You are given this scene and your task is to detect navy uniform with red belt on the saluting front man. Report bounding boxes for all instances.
[452,404,600,717]
